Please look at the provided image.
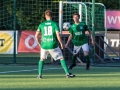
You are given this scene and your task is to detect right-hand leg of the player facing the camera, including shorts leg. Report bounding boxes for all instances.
[82,44,90,70]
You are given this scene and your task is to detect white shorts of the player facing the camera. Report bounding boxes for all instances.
[73,43,89,54]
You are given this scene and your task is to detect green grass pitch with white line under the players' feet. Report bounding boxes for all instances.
[0,65,120,90]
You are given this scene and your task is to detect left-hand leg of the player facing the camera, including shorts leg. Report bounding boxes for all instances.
[69,46,81,69]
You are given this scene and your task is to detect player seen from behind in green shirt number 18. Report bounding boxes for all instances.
[35,10,75,79]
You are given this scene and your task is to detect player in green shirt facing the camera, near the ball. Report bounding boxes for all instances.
[65,13,94,70]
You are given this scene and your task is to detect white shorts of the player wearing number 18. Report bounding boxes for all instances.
[40,47,63,60]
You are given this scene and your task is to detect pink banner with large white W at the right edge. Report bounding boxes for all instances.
[106,11,120,29]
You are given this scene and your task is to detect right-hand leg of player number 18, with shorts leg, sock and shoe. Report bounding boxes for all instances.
[49,47,75,77]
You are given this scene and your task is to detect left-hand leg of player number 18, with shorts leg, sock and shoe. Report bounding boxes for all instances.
[38,48,48,79]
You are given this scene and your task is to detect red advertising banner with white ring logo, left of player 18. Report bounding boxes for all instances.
[18,31,40,53]
